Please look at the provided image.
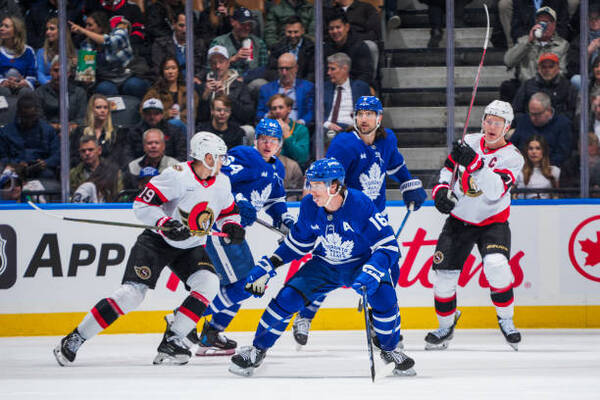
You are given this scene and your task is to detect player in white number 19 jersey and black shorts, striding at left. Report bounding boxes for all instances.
[54,132,245,366]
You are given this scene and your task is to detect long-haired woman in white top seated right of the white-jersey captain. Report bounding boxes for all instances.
[515,135,560,199]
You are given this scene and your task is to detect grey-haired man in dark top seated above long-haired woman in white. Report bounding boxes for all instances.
[510,92,572,167]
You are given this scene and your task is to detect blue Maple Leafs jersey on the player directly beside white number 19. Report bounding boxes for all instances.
[221,146,287,225]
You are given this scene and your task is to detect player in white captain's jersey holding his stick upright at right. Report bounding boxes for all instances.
[425,100,524,350]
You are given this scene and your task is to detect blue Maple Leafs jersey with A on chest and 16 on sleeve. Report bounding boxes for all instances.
[275,189,400,271]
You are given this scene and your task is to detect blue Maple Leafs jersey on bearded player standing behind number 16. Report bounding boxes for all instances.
[326,129,412,212]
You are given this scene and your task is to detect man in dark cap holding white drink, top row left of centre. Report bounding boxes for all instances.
[209,7,268,82]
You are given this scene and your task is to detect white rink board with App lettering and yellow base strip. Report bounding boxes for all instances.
[0,200,600,336]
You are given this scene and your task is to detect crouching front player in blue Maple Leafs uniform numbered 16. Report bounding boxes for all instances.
[229,158,415,376]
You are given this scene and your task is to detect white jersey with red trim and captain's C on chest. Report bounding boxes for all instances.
[432,133,524,225]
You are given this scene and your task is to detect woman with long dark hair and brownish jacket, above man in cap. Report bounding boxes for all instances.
[142,56,198,131]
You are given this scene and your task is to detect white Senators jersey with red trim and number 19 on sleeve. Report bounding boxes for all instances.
[133,161,240,249]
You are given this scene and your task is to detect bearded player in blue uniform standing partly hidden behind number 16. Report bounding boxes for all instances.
[293,96,427,348]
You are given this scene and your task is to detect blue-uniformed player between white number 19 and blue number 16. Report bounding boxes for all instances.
[178,118,295,356]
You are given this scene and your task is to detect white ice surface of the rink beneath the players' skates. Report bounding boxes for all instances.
[0,329,600,400]
